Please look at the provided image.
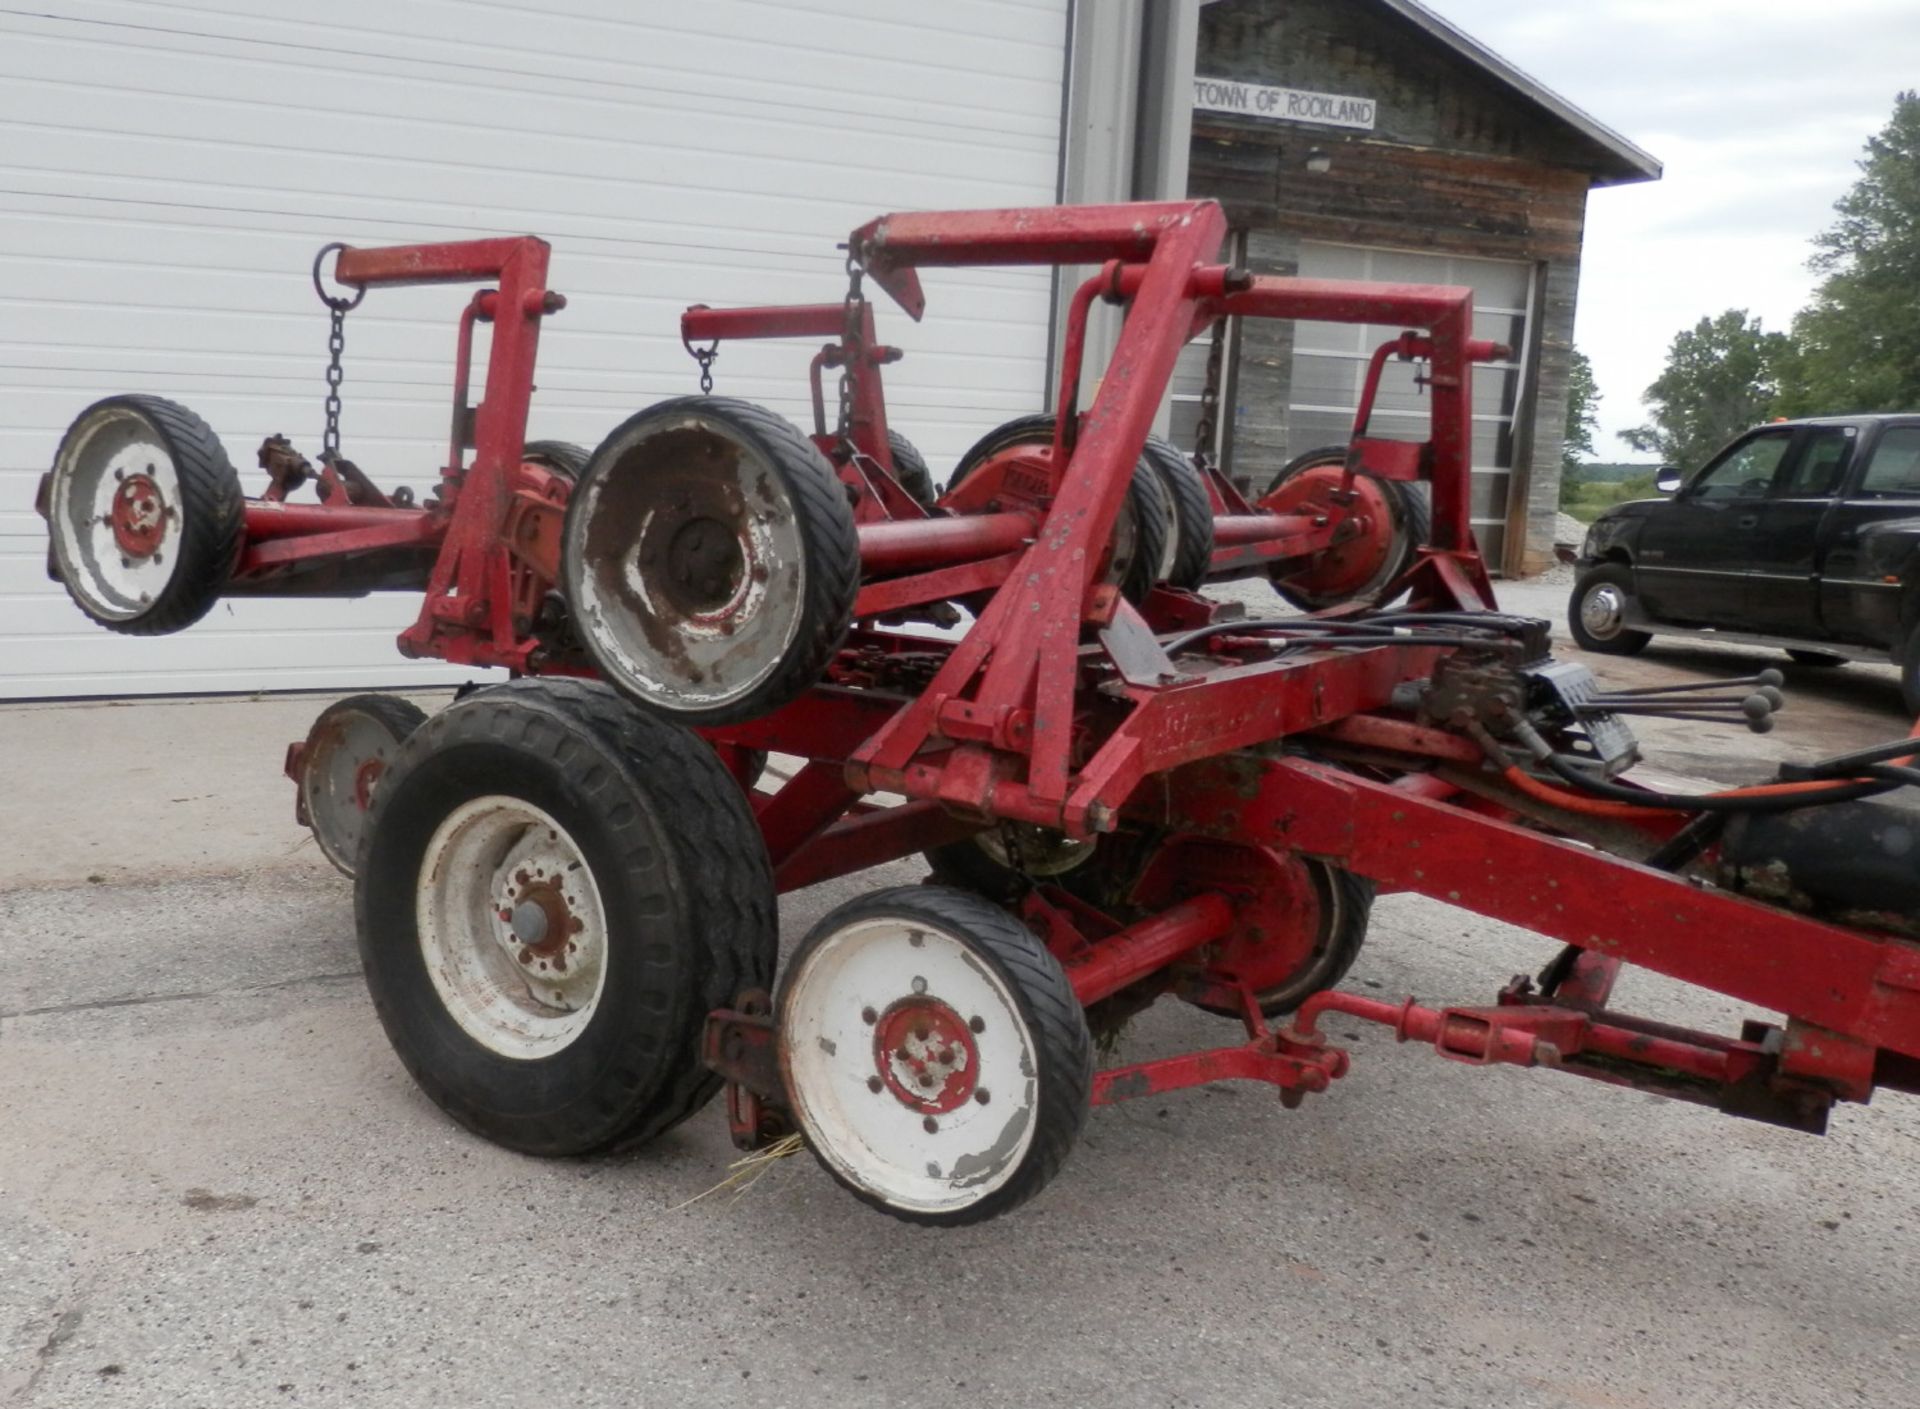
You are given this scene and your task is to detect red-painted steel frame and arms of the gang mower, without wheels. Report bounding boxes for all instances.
[224,202,1920,1140]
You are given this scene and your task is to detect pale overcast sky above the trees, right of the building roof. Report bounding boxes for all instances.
[1427,0,1920,459]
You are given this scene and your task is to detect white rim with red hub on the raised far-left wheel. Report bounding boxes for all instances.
[50,407,182,622]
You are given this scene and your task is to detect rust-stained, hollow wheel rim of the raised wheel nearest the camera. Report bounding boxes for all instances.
[570,413,806,712]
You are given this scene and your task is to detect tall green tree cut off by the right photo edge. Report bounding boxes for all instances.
[1780,92,1920,417]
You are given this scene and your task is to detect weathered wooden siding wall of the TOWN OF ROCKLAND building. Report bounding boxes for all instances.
[1188,0,1590,572]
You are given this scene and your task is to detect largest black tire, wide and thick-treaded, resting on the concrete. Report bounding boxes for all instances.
[353,680,780,1156]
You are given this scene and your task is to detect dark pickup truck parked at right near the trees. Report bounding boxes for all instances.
[1567,413,1920,714]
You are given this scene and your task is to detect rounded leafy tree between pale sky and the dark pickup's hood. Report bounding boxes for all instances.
[1622,309,1791,468]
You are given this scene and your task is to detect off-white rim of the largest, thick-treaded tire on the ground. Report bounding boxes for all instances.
[415,797,607,1062]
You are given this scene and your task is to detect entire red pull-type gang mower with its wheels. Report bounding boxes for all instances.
[42,203,1920,1223]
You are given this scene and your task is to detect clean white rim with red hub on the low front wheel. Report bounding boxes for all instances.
[780,918,1039,1213]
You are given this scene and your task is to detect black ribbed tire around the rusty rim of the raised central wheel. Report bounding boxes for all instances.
[561,395,860,728]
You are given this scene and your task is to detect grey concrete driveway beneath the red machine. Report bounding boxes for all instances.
[0,593,1920,1409]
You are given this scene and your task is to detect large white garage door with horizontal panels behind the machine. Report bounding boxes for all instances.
[0,0,1068,699]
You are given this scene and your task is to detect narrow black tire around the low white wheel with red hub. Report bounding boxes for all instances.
[774,885,1092,1229]
